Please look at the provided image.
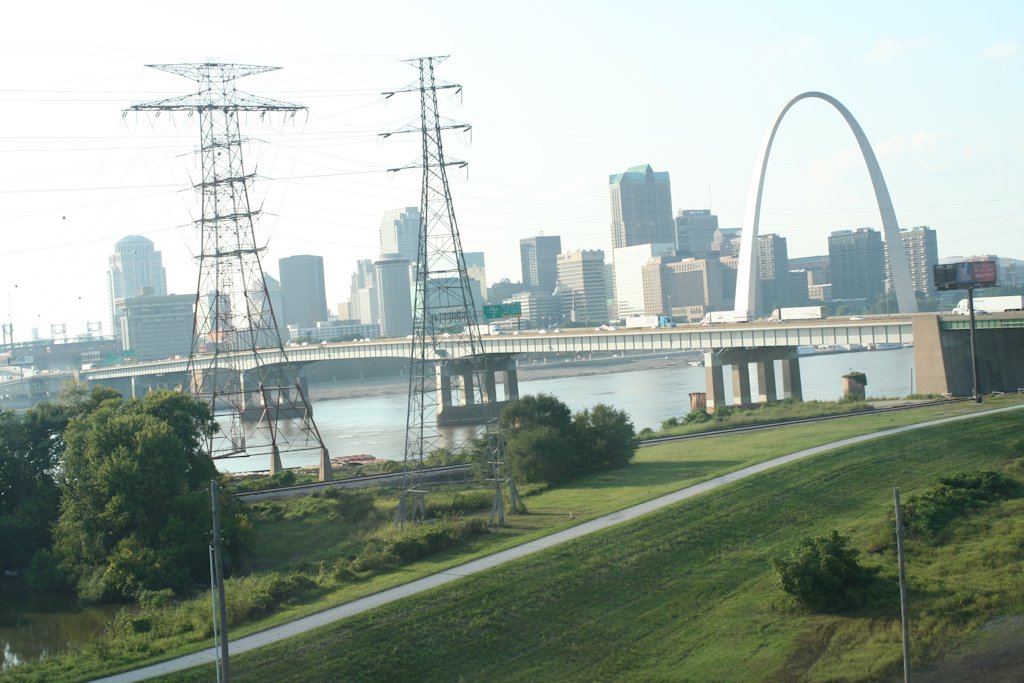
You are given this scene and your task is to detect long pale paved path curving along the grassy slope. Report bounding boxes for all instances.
[99,404,1024,683]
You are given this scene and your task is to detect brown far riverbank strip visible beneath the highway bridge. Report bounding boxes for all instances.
[309,351,699,401]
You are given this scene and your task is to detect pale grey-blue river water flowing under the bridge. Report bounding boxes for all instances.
[217,348,913,472]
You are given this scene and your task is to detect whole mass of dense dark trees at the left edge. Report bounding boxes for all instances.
[0,387,239,599]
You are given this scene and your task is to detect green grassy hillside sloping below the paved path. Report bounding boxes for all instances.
[153,414,1024,681]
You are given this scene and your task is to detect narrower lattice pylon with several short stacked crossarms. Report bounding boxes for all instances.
[383,56,519,521]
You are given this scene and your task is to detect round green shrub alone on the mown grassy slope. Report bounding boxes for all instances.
[771,529,876,611]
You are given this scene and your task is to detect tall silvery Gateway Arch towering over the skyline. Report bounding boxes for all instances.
[735,91,918,317]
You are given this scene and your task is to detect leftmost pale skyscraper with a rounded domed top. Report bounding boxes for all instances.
[106,234,167,348]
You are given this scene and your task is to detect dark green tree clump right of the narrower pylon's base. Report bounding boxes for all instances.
[501,393,636,484]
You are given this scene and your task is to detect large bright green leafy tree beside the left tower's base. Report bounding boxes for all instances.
[54,391,237,599]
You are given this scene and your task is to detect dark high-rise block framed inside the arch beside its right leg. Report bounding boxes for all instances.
[828,227,886,306]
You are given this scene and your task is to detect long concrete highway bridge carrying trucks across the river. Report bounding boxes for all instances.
[0,311,1024,410]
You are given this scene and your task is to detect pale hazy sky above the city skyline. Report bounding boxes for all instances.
[0,0,1024,340]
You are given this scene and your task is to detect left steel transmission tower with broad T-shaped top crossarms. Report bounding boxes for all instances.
[128,63,331,479]
